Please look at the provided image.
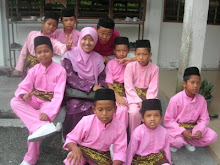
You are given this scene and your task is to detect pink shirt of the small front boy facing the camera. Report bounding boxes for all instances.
[125,124,171,165]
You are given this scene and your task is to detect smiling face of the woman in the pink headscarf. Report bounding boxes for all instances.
[80,34,95,53]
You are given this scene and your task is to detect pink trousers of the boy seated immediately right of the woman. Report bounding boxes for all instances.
[115,100,128,128]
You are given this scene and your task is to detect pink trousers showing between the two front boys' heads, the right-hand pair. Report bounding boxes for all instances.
[128,104,141,135]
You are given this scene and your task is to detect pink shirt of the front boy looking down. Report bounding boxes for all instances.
[63,115,127,162]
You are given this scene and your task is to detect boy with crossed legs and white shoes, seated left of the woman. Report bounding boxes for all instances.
[11,36,66,165]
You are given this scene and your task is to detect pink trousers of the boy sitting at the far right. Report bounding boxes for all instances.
[170,128,218,148]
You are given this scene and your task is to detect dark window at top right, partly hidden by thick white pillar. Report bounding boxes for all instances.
[164,0,220,24]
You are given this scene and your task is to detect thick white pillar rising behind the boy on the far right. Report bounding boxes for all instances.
[177,0,209,91]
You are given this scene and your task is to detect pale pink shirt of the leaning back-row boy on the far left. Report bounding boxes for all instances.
[15,31,67,72]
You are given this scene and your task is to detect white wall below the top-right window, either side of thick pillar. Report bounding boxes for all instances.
[158,22,220,69]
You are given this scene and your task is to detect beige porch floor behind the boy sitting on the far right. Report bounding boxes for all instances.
[159,70,220,164]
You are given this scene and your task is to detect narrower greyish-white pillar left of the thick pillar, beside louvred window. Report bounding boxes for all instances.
[144,0,164,64]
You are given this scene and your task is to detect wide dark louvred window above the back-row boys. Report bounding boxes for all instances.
[7,0,146,21]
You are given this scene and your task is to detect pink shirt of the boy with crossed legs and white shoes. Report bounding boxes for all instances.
[15,62,66,121]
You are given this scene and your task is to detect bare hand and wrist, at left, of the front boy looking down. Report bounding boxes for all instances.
[66,143,83,165]
